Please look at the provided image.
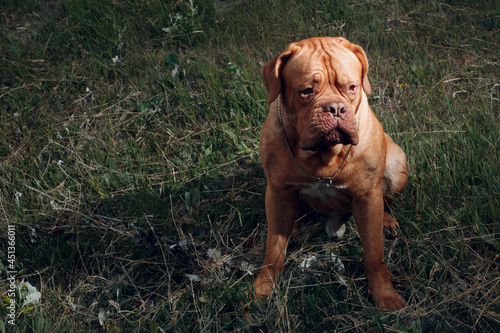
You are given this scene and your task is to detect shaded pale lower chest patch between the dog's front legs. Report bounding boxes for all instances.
[296,181,351,213]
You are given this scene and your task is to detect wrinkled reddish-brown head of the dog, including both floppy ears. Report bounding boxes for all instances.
[262,37,371,150]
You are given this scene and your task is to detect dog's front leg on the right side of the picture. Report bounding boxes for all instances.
[353,187,406,311]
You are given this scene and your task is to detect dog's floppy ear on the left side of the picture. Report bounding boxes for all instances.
[262,43,299,104]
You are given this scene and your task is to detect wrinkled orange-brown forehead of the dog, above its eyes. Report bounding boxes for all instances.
[283,41,362,84]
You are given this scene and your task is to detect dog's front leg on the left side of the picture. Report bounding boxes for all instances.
[254,185,299,298]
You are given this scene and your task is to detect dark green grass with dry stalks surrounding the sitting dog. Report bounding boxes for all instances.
[0,0,500,332]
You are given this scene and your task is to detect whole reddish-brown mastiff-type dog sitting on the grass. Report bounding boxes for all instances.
[254,38,408,310]
